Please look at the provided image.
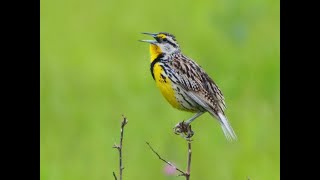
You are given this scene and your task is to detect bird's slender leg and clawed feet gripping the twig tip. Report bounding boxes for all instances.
[173,112,204,138]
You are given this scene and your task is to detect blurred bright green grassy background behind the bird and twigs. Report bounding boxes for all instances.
[40,0,280,180]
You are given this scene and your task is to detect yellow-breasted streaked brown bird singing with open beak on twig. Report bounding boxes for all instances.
[140,32,237,141]
